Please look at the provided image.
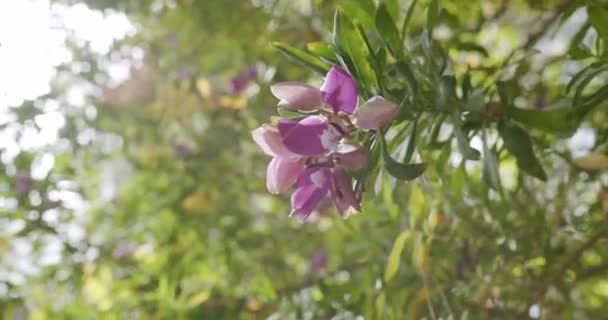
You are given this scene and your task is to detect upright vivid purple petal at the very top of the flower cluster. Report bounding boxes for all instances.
[321,67,357,115]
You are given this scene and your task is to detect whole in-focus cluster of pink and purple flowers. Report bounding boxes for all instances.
[252,67,398,219]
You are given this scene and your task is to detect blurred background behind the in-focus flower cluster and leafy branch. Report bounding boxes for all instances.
[0,0,608,320]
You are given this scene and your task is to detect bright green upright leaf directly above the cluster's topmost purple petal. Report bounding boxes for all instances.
[334,11,378,92]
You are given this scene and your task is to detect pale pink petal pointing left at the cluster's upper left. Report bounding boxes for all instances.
[270,82,321,111]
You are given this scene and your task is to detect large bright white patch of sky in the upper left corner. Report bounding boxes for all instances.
[0,0,135,109]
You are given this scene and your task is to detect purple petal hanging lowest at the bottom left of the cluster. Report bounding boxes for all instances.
[291,167,331,219]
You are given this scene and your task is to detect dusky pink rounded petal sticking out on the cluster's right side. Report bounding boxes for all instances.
[355,96,399,130]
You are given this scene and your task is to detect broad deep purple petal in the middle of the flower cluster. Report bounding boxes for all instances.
[279,116,342,156]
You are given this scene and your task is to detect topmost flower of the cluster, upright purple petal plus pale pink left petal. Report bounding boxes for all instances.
[270,67,357,115]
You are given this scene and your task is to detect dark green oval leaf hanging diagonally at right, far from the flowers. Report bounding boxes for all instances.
[498,121,547,181]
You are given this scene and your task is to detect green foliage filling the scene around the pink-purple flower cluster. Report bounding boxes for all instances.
[0,0,608,319]
